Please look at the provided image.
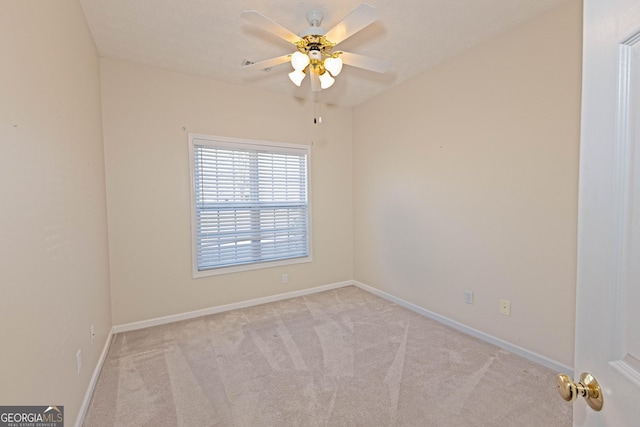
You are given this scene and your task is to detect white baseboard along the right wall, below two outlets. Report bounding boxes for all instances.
[353,281,573,378]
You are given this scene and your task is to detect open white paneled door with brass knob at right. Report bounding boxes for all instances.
[574,0,640,426]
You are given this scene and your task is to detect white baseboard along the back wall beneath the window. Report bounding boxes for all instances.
[113,280,355,334]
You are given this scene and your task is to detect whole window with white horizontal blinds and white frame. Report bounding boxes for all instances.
[189,134,311,277]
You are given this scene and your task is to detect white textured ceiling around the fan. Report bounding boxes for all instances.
[80,0,565,107]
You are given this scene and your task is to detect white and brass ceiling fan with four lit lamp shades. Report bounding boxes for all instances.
[240,3,389,92]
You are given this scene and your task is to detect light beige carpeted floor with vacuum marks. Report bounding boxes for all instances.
[84,286,572,427]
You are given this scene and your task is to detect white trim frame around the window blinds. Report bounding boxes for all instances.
[188,133,313,279]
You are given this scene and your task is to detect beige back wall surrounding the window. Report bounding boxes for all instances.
[101,59,353,325]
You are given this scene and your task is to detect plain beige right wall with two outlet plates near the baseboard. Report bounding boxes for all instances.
[353,0,582,366]
